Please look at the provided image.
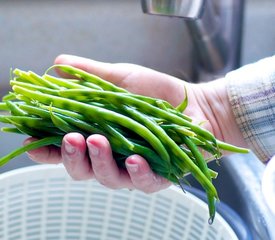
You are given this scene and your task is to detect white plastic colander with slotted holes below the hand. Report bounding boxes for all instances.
[0,165,238,240]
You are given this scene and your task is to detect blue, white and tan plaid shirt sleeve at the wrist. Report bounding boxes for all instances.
[226,55,275,162]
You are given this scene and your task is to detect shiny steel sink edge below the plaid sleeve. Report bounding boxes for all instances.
[221,154,275,240]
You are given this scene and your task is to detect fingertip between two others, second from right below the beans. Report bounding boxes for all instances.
[86,134,132,189]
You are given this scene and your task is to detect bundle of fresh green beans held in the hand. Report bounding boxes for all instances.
[0,65,248,222]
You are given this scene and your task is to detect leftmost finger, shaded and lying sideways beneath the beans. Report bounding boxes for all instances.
[24,137,62,164]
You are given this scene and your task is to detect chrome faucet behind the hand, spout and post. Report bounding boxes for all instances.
[141,0,244,81]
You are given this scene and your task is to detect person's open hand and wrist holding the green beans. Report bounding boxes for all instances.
[28,55,248,193]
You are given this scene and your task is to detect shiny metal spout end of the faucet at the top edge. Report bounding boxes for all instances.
[141,0,205,20]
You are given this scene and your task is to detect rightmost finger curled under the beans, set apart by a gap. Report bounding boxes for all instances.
[126,155,171,193]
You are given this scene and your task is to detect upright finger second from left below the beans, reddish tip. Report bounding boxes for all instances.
[61,133,94,180]
